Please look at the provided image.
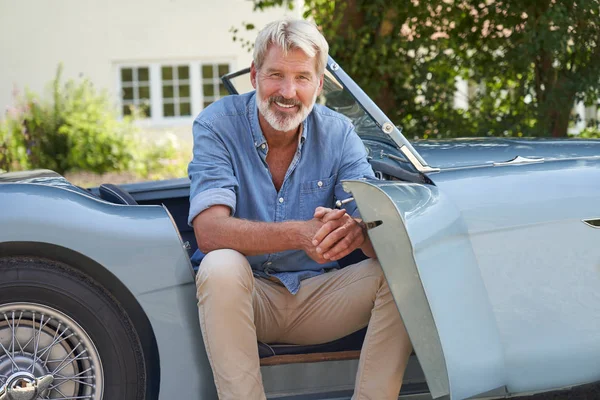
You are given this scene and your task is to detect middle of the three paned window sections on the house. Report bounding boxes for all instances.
[161,65,192,117]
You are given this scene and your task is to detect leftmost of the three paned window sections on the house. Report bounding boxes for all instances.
[121,67,152,117]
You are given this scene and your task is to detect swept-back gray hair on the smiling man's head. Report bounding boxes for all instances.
[254,19,329,74]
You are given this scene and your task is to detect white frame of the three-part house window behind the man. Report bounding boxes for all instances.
[114,57,236,126]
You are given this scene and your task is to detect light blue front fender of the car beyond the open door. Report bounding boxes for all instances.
[432,159,600,392]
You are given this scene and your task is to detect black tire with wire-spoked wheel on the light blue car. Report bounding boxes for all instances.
[0,257,151,400]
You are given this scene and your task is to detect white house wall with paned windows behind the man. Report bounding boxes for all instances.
[0,0,302,141]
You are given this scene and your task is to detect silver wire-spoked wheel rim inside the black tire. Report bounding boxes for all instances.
[0,303,104,400]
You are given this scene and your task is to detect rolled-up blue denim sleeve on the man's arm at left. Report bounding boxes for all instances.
[188,120,238,226]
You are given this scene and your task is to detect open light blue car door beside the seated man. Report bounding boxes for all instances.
[344,181,506,399]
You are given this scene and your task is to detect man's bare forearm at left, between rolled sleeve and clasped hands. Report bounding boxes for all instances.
[194,216,312,256]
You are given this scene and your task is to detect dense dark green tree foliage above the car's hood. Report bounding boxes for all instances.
[239,0,600,137]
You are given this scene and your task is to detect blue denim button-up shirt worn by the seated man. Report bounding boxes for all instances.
[188,92,374,294]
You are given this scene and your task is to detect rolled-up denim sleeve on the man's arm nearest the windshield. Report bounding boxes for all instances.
[335,128,375,218]
